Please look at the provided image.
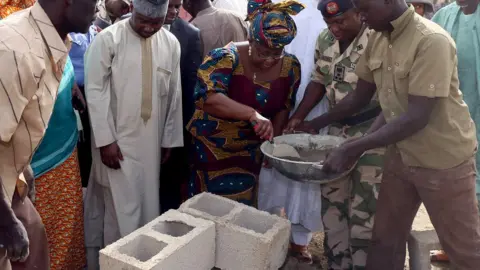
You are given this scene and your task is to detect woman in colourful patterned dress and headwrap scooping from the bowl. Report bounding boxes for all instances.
[187,0,304,205]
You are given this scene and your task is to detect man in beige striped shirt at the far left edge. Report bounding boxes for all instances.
[0,0,95,270]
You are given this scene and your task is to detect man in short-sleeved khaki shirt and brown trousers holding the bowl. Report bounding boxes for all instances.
[296,0,480,270]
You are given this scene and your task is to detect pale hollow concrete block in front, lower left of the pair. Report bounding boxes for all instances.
[100,210,215,270]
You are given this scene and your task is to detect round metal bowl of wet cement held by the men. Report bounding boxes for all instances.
[260,134,357,184]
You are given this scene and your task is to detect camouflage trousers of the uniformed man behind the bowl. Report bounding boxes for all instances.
[322,125,385,270]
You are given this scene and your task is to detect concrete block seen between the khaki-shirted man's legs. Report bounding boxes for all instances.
[408,205,442,270]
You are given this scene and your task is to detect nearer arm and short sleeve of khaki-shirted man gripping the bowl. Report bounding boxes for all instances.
[327,34,457,171]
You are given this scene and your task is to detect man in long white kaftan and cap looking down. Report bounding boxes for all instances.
[85,0,183,270]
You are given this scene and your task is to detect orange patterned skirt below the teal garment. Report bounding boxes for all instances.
[35,149,86,270]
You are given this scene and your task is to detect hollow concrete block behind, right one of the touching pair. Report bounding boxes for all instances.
[180,193,291,270]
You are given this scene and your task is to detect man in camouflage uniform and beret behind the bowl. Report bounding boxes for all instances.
[287,0,384,269]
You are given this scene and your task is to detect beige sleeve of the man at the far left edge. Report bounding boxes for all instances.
[0,50,38,143]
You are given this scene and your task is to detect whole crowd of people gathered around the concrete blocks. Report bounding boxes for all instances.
[0,0,480,270]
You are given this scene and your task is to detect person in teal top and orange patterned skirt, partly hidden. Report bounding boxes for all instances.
[31,57,86,270]
